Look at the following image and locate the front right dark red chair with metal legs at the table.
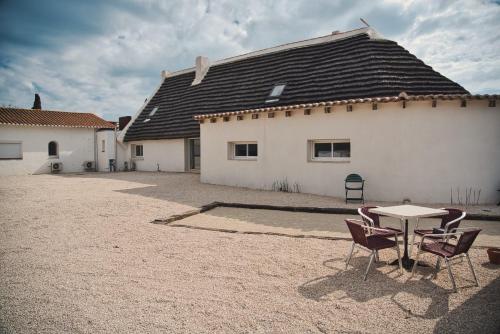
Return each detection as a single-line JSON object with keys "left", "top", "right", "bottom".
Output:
{"left": 411, "top": 228, "right": 481, "bottom": 292}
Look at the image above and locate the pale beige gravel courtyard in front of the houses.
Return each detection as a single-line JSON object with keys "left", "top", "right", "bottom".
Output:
{"left": 0, "top": 173, "right": 500, "bottom": 333}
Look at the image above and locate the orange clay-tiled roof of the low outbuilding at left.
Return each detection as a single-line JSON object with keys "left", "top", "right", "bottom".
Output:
{"left": 0, "top": 107, "right": 115, "bottom": 129}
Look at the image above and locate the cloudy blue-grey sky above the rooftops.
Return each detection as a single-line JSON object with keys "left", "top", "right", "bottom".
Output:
{"left": 0, "top": 0, "right": 500, "bottom": 120}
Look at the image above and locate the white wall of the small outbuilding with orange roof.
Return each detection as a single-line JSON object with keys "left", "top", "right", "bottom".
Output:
{"left": 0, "top": 125, "right": 95, "bottom": 175}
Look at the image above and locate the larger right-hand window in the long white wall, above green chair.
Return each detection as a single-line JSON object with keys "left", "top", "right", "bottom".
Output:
{"left": 309, "top": 139, "right": 351, "bottom": 161}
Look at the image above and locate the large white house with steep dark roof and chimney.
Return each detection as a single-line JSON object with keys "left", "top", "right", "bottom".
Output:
{"left": 120, "top": 28, "right": 500, "bottom": 203}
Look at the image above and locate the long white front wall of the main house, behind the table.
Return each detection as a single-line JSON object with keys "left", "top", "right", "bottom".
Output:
{"left": 201, "top": 100, "right": 500, "bottom": 203}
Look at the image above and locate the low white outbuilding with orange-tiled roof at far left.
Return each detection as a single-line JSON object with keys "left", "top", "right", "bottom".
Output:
{"left": 0, "top": 108, "right": 116, "bottom": 175}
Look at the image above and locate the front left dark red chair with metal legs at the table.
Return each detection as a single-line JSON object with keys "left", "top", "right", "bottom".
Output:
{"left": 345, "top": 219, "right": 403, "bottom": 281}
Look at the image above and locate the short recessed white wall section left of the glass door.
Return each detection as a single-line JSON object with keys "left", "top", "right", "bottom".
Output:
{"left": 127, "top": 139, "right": 185, "bottom": 172}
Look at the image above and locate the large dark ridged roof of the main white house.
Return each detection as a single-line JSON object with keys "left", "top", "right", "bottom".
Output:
{"left": 125, "top": 33, "right": 468, "bottom": 141}
